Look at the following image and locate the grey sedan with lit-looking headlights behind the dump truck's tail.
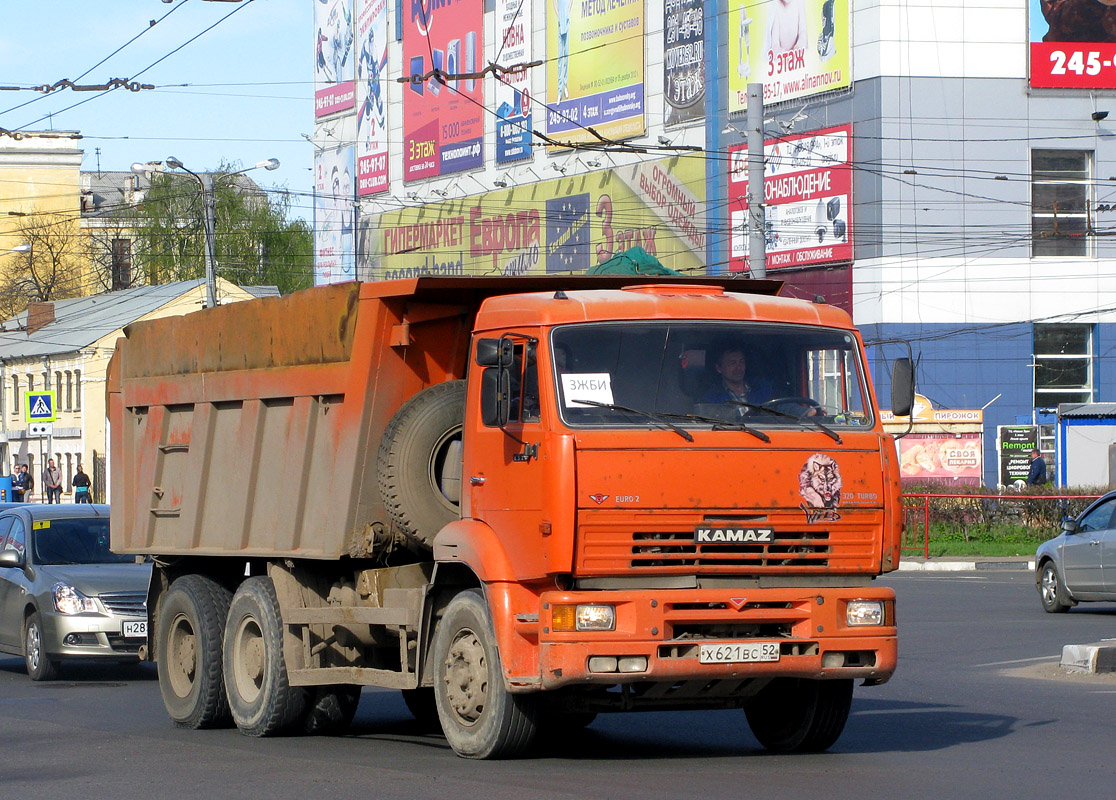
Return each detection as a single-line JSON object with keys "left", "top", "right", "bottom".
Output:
{"left": 0, "top": 504, "right": 151, "bottom": 681}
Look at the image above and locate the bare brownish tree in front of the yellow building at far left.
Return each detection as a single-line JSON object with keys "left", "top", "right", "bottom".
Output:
{"left": 0, "top": 211, "right": 85, "bottom": 319}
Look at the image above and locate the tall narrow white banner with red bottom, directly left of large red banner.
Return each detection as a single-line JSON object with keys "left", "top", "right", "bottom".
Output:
{"left": 356, "top": 0, "right": 387, "bottom": 197}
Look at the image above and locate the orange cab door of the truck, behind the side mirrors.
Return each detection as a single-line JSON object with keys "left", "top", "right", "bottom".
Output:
{"left": 462, "top": 330, "right": 550, "bottom": 578}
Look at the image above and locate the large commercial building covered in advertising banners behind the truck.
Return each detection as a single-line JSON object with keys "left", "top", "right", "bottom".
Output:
{"left": 308, "top": 0, "right": 1116, "bottom": 485}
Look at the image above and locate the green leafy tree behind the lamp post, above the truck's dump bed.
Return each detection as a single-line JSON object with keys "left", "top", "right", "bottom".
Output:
{"left": 128, "top": 164, "right": 314, "bottom": 295}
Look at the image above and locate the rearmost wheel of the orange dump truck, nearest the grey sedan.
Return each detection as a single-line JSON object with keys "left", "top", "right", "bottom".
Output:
{"left": 155, "top": 575, "right": 232, "bottom": 729}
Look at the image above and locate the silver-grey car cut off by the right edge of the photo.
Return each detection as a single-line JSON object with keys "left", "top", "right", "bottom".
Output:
{"left": 1035, "top": 492, "right": 1116, "bottom": 614}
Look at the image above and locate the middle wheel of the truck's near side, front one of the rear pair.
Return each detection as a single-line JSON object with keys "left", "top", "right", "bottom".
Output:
{"left": 224, "top": 577, "right": 307, "bottom": 736}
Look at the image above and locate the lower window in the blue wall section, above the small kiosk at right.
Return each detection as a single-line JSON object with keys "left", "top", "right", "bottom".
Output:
{"left": 1035, "top": 324, "right": 1093, "bottom": 408}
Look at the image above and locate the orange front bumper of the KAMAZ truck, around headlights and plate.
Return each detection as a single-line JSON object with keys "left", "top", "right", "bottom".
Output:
{"left": 539, "top": 587, "right": 897, "bottom": 690}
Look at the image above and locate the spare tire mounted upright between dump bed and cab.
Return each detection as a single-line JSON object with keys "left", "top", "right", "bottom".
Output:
{"left": 376, "top": 380, "right": 465, "bottom": 548}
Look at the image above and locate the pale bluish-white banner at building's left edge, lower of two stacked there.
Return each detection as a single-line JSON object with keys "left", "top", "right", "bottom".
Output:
{"left": 314, "top": 145, "right": 356, "bottom": 286}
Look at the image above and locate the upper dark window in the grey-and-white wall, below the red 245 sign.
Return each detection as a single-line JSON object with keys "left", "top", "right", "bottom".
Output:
{"left": 1031, "top": 150, "right": 1093, "bottom": 257}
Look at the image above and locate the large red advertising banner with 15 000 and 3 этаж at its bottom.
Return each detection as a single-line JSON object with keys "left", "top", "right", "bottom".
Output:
{"left": 403, "top": 0, "right": 485, "bottom": 182}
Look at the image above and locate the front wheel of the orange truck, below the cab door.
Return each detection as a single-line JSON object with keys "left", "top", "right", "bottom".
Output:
{"left": 434, "top": 589, "right": 537, "bottom": 759}
